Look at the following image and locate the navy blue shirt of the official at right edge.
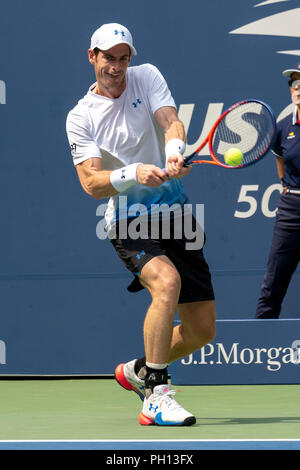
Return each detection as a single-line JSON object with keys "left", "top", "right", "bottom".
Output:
{"left": 272, "top": 108, "right": 300, "bottom": 188}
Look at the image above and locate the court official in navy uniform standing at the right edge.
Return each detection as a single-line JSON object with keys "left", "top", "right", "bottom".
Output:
{"left": 255, "top": 62, "right": 300, "bottom": 319}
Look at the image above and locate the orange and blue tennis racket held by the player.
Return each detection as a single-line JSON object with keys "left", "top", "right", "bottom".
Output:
{"left": 185, "top": 100, "right": 276, "bottom": 170}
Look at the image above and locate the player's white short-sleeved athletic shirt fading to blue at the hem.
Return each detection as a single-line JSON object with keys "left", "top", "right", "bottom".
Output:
{"left": 66, "top": 64, "right": 187, "bottom": 231}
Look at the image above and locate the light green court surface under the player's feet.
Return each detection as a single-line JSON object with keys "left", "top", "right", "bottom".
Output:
{"left": 0, "top": 378, "right": 300, "bottom": 440}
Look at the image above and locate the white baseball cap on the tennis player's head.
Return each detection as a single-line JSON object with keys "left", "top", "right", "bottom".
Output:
{"left": 91, "top": 23, "right": 137, "bottom": 55}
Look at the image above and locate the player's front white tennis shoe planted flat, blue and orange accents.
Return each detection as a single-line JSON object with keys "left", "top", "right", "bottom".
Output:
{"left": 139, "top": 384, "right": 196, "bottom": 426}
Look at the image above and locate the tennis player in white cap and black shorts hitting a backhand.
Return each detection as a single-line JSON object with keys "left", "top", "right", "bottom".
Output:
{"left": 67, "top": 23, "right": 216, "bottom": 426}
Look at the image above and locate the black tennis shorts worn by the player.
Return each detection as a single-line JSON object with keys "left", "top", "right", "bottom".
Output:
{"left": 110, "top": 217, "right": 215, "bottom": 303}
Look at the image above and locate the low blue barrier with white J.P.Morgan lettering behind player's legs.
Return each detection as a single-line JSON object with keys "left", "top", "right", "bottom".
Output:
{"left": 170, "top": 320, "right": 300, "bottom": 385}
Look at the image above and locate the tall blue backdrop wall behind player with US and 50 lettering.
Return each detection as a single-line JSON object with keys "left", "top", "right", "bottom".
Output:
{"left": 0, "top": 0, "right": 300, "bottom": 378}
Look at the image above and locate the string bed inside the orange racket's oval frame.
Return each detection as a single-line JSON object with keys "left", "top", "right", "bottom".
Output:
{"left": 211, "top": 102, "right": 274, "bottom": 165}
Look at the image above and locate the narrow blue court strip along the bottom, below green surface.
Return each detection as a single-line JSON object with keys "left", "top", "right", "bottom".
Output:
{"left": 0, "top": 439, "right": 300, "bottom": 450}
